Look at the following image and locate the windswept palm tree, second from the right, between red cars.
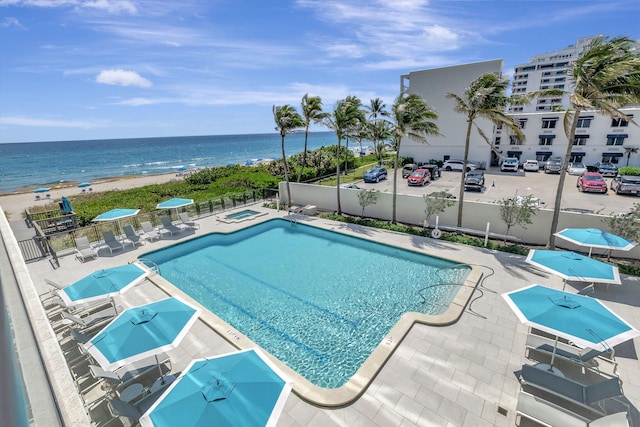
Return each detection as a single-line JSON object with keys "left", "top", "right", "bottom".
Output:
{"left": 447, "top": 73, "right": 524, "bottom": 227}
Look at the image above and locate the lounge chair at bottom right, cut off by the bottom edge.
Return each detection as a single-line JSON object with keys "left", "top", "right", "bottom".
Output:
{"left": 516, "top": 391, "right": 629, "bottom": 427}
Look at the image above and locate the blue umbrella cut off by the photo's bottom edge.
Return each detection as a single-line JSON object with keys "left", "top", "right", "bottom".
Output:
{"left": 140, "top": 349, "right": 292, "bottom": 427}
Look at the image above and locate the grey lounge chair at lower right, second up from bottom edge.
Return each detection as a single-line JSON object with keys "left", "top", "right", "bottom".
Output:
{"left": 520, "top": 365, "right": 626, "bottom": 415}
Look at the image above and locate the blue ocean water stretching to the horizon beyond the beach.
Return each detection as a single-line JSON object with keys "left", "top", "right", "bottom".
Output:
{"left": 0, "top": 132, "right": 337, "bottom": 194}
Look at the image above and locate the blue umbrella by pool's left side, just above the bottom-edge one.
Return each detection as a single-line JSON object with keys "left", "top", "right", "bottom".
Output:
{"left": 84, "top": 297, "right": 200, "bottom": 370}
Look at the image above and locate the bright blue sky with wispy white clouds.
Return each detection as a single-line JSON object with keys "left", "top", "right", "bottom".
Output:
{"left": 0, "top": 0, "right": 640, "bottom": 142}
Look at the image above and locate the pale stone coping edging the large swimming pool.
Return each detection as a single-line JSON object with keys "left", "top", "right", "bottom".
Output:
{"left": 141, "top": 213, "right": 483, "bottom": 407}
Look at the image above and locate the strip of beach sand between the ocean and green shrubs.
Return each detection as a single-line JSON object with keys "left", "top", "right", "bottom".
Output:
{"left": 0, "top": 173, "right": 182, "bottom": 221}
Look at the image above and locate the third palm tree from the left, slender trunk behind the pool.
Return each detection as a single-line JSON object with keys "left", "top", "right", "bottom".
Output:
{"left": 323, "top": 96, "right": 364, "bottom": 215}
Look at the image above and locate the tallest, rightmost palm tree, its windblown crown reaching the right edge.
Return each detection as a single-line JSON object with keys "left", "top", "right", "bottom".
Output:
{"left": 548, "top": 36, "right": 640, "bottom": 249}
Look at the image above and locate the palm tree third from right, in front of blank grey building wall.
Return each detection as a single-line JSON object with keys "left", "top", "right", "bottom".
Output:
{"left": 390, "top": 93, "right": 440, "bottom": 223}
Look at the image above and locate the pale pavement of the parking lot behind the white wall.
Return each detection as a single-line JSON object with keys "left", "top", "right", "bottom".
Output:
{"left": 356, "top": 168, "right": 640, "bottom": 215}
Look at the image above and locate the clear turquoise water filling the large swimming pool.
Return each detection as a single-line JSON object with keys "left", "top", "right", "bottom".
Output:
{"left": 145, "top": 219, "right": 470, "bottom": 388}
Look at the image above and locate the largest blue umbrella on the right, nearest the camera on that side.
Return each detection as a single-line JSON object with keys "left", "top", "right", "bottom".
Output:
{"left": 502, "top": 285, "right": 640, "bottom": 351}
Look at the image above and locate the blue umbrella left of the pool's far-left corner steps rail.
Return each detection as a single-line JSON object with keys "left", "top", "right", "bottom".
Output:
{"left": 59, "top": 264, "right": 149, "bottom": 306}
